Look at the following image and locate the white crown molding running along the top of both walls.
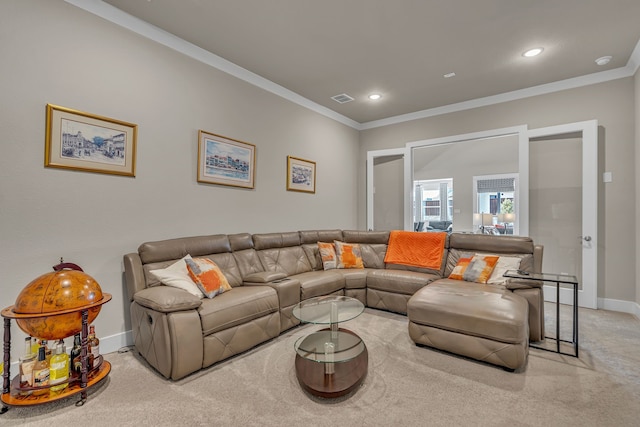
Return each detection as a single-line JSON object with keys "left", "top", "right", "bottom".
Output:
{"left": 65, "top": 0, "right": 640, "bottom": 131}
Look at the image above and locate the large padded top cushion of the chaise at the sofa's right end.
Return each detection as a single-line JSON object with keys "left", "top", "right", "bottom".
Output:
{"left": 407, "top": 279, "right": 529, "bottom": 343}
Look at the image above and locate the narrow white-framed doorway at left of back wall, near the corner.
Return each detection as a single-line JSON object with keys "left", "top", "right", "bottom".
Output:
{"left": 367, "top": 148, "right": 412, "bottom": 230}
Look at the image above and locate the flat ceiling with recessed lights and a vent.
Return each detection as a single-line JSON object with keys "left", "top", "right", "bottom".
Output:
{"left": 82, "top": 0, "right": 640, "bottom": 128}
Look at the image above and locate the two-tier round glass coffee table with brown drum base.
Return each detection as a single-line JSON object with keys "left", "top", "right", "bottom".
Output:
{"left": 293, "top": 296, "right": 369, "bottom": 398}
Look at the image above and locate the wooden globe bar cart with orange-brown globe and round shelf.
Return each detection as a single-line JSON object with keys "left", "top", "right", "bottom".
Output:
{"left": 0, "top": 263, "right": 111, "bottom": 414}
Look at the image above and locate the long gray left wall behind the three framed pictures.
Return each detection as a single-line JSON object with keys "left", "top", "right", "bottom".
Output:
{"left": 0, "top": 0, "right": 359, "bottom": 356}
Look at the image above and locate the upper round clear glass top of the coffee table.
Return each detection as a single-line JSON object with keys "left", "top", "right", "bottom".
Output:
{"left": 293, "top": 295, "right": 364, "bottom": 325}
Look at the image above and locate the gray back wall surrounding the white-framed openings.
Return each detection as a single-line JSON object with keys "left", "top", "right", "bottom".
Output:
{"left": 358, "top": 77, "right": 640, "bottom": 301}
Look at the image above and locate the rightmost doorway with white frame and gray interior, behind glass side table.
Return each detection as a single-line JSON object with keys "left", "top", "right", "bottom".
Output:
{"left": 529, "top": 120, "right": 598, "bottom": 308}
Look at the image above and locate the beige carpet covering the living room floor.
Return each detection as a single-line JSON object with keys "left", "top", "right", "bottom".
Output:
{"left": 0, "top": 304, "right": 640, "bottom": 427}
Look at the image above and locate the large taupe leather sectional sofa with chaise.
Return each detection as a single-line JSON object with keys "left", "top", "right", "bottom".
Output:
{"left": 124, "top": 230, "right": 544, "bottom": 380}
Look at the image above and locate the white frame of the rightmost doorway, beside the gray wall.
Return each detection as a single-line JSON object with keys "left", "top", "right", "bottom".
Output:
{"left": 527, "top": 120, "right": 599, "bottom": 309}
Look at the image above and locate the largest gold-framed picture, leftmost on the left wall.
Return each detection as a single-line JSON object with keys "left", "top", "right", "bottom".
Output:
{"left": 44, "top": 104, "right": 138, "bottom": 176}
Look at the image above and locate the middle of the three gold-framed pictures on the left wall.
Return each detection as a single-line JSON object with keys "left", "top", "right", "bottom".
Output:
{"left": 198, "top": 130, "right": 256, "bottom": 188}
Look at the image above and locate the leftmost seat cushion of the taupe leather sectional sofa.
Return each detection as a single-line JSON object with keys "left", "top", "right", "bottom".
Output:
{"left": 198, "top": 286, "right": 278, "bottom": 336}
